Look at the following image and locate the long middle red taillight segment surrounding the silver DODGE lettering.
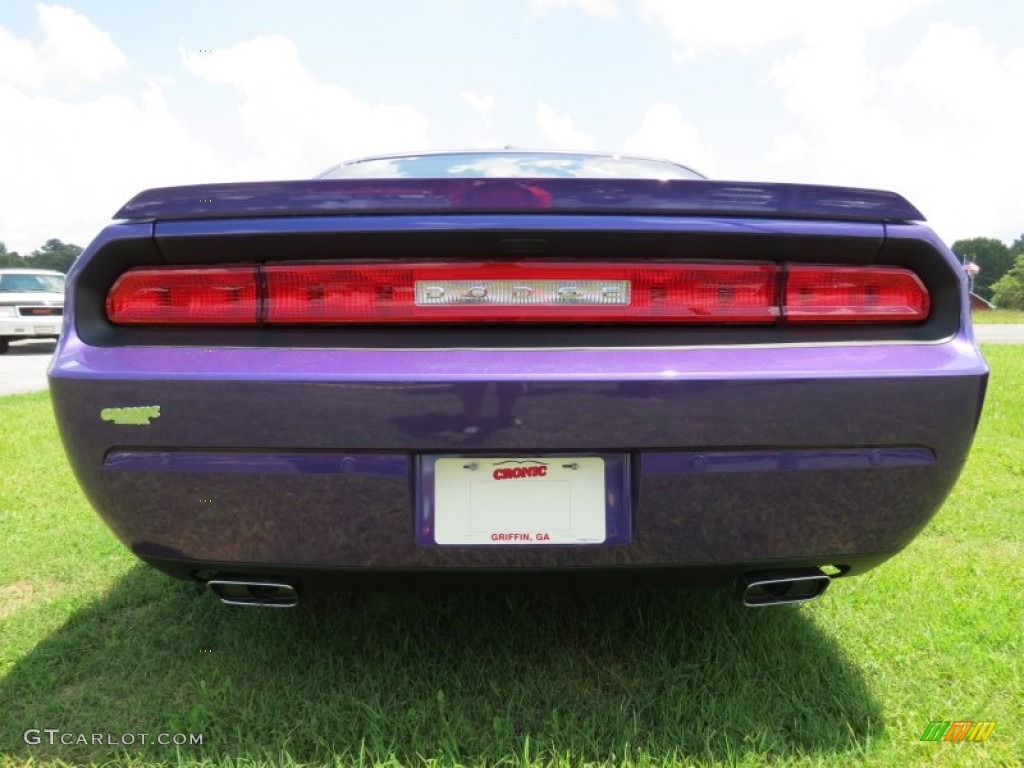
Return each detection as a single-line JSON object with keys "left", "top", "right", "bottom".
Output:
{"left": 264, "top": 262, "right": 778, "bottom": 324}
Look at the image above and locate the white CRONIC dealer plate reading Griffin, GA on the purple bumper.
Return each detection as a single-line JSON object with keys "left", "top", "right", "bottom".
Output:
{"left": 433, "top": 456, "right": 607, "bottom": 547}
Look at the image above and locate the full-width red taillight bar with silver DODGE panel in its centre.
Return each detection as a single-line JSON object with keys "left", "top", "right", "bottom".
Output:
{"left": 106, "top": 261, "right": 929, "bottom": 326}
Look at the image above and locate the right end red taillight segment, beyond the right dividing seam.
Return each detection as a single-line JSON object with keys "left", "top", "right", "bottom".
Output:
{"left": 782, "top": 264, "right": 930, "bottom": 323}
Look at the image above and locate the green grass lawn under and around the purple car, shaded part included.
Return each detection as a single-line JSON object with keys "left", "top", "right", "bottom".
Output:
{"left": 0, "top": 345, "right": 1024, "bottom": 768}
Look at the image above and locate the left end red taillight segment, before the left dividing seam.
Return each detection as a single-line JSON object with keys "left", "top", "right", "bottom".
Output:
{"left": 106, "top": 266, "right": 259, "bottom": 325}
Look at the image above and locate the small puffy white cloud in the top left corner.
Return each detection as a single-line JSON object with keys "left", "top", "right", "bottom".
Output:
{"left": 0, "top": 3, "right": 127, "bottom": 90}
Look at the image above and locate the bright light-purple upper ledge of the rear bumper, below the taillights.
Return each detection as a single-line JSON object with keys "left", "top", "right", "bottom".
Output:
{"left": 50, "top": 334, "right": 985, "bottom": 387}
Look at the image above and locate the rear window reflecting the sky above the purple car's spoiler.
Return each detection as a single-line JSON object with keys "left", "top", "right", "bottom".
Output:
{"left": 317, "top": 152, "right": 703, "bottom": 180}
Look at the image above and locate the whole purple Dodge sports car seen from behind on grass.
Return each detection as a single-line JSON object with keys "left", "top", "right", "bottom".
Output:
{"left": 49, "top": 151, "right": 988, "bottom": 606}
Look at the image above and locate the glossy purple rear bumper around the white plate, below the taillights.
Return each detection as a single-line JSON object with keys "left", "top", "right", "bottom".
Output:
{"left": 50, "top": 337, "right": 987, "bottom": 581}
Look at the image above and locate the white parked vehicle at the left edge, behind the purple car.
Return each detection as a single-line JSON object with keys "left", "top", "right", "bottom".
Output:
{"left": 0, "top": 268, "right": 65, "bottom": 354}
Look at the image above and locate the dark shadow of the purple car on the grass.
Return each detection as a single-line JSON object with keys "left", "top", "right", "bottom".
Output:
{"left": 0, "top": 565, "right": 883, "bottom": 765}
